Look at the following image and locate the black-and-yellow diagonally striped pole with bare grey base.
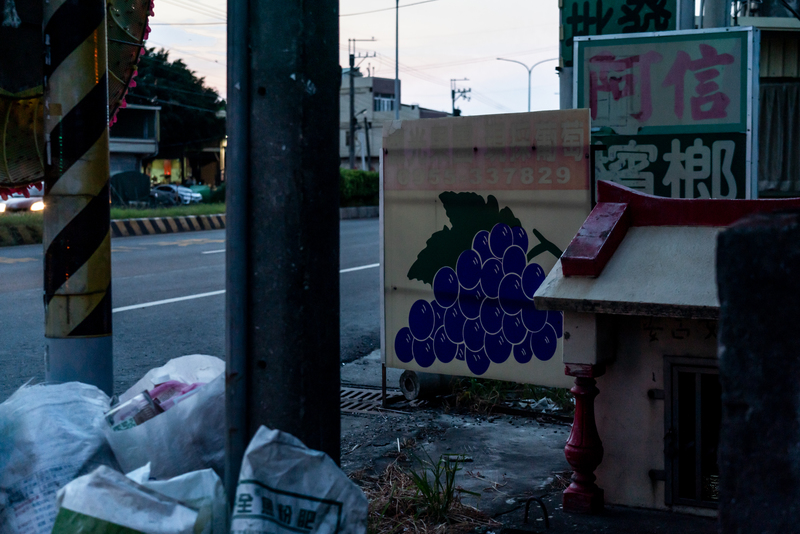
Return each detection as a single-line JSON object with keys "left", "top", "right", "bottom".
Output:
{"left": 43, "top": 0, "right": 114, "bottom": 395}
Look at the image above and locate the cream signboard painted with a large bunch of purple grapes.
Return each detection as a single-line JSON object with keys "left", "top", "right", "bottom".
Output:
{"left": 381, "top": 110, "right": 590, "bottom": 387}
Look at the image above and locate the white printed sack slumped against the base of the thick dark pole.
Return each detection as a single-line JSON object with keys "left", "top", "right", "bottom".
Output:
{"left": 231, "top": 426, "right": 368, "bottom": 534}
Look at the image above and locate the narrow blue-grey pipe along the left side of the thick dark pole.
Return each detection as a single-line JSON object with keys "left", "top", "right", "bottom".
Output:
{"left": 225, "top": 0, "right": 252, "bottom": 502}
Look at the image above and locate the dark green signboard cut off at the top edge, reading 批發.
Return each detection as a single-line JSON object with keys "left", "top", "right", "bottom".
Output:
{"left": 561, "top": 0, "right": 679, "bottom": 67}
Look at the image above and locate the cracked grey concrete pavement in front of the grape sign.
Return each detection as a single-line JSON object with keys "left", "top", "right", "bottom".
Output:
{"left": 341, "top": 351, "right": 717, "bottom": 534}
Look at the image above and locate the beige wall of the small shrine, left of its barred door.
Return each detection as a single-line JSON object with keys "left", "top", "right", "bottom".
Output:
{"left": 595, "top": 316, "right": 717, "bottom": 515}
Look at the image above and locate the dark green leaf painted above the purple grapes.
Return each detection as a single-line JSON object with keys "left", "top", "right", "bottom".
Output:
{"left": 408, "top": 191, "right": 522, "bottom": 284}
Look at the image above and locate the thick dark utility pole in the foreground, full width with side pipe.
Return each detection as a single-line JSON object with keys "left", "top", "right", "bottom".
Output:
{"left": 225, "top": 0, "right": 341, "bottom": 498}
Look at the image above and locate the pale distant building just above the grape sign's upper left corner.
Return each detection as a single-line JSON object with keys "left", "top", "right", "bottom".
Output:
{"left": 339, "top": 69, "right": 452, "bottom": 170}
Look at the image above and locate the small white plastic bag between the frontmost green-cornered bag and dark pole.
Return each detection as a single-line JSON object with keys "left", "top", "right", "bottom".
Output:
{"left": 128, "top": 464, "right": 228, "bottom": 534}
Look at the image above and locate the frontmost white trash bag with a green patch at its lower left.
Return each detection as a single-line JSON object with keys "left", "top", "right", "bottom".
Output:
{"left": 53, "top": 467, "right": 197, "bottom": 534}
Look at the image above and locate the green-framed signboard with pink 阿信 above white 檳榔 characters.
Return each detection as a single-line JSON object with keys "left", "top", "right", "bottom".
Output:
{"left": 574, "top": 28, "right": 758, "bottom": 198}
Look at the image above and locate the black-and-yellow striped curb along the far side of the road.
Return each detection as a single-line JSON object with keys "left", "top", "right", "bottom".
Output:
{"left": 0, "top": 206, "right": 378, "bottom": 247}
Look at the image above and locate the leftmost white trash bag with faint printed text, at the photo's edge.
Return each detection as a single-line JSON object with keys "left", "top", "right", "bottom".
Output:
{"left": 0, "top": 382, "right": 117, "bottom": 534}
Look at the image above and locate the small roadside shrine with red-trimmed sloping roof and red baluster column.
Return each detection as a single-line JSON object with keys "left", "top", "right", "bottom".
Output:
{"left": 534, "top": 181, "right": 800, "bottom": 515}
